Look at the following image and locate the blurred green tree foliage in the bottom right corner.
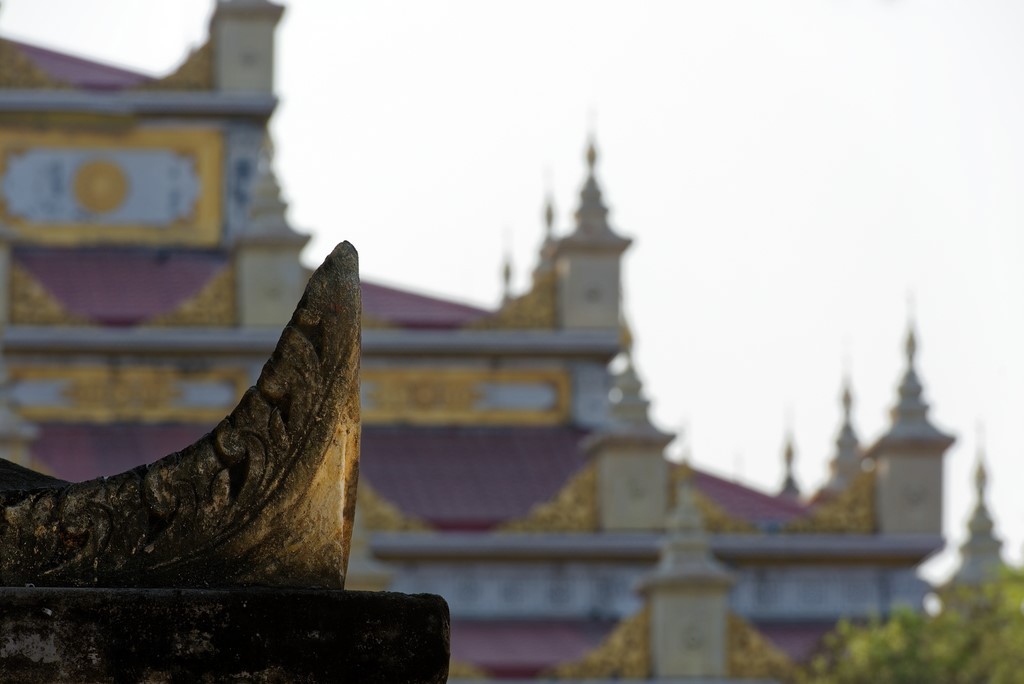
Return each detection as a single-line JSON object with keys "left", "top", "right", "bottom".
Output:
{"left": 799, "top": 570, "right": 1024, "bottom": 684}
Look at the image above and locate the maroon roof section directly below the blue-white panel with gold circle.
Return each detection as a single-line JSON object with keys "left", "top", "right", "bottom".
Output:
{"left": 14, "top": 248, "right": 227, "bottom": 326}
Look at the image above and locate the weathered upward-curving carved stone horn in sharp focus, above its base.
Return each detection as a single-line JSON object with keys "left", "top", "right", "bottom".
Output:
{"left": 0, "top": 243, "right": 360, "bottom": 589}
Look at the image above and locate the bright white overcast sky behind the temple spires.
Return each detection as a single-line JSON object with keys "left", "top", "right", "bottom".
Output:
{"left": 0, "top": 0, "right": 1024, "bottom": 576}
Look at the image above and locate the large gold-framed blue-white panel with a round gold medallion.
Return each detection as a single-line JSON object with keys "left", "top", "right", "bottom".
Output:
{"left": 0, "top": 128, "right": 223, "bottom": 247}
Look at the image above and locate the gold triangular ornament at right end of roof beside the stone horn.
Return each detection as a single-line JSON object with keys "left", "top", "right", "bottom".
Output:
{"left": 497, "top": 461, "right": 598, "bottom": 533}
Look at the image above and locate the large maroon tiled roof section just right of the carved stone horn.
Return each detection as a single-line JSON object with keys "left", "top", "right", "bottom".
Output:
{"left": 359, "top": 426, "right": 586, "bottom": 530}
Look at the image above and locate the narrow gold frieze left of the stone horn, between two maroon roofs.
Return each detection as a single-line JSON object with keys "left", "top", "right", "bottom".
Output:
{"left": 10, "top": 366, "right": 249, "bottom": 423}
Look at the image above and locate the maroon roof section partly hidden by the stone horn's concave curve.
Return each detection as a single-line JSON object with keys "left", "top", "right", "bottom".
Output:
{"left": 32, "top": 423, "right": 210, "bottom": 482}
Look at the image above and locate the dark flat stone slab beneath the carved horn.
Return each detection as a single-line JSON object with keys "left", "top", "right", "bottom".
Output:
{"left": 0, "top": 587, "right": 449, "bottom": 684}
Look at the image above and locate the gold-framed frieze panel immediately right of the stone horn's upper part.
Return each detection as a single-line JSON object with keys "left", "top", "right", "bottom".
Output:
{"left": 362, "top": 367, "right": 569, "bottom": 425}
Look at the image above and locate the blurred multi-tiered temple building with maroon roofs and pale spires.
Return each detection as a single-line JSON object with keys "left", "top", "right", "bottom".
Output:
{"left": 0, "top": 0, "right": 998, "bottom": 681}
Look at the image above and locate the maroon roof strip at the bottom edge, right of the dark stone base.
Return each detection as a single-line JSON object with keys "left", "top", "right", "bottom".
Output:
{"left": 452, "top": 621, "right": 615, "bottom": 679}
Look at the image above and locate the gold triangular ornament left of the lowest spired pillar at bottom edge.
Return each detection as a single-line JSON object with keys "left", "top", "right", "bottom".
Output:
{"left": 541, "top": 606, "right": 650, "bottom": 680}
